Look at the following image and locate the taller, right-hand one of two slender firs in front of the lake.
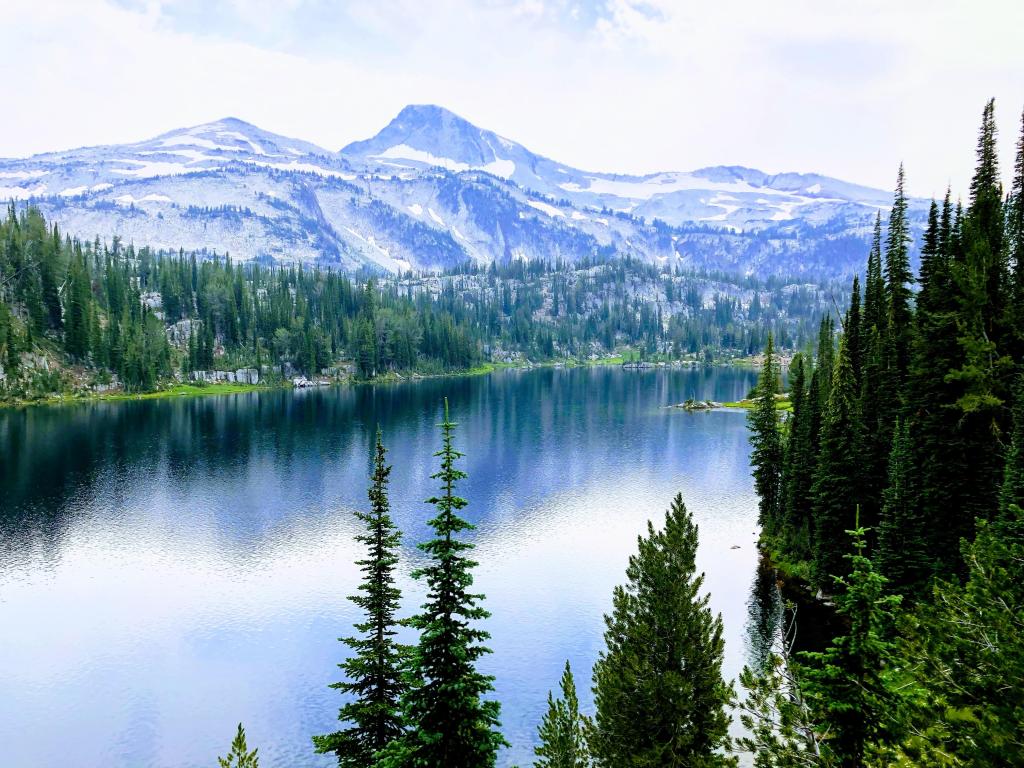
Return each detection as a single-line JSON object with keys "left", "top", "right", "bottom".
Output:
{"left": 382, "top": 399, "right": 505, "bottom": 768}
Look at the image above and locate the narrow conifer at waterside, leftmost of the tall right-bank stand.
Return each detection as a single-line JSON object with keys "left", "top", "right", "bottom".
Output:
{"left": 748, "top": 334, "right": 782, "bottom": 536}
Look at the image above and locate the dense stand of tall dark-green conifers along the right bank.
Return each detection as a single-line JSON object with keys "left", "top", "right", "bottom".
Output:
{"left": 744, "top": 101, "right": 1024, "bottom": 766}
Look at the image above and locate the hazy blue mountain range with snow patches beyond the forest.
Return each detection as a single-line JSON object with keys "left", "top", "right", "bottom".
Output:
{"left": 0, "top": 105, "right": 925, "bottom": 278}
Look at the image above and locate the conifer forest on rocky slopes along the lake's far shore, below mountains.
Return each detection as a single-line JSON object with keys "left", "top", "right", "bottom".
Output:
{"left": 0, "top": 206, "right": 834, "bottom": 397}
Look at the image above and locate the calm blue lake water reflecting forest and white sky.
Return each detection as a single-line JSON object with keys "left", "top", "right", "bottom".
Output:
{"left": 0, "top": 369, "right": 770, "bottom": 768}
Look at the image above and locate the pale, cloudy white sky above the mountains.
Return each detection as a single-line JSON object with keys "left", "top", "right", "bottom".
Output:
{"left": 0, "top": 0, "right": 1024, "bottom": 197}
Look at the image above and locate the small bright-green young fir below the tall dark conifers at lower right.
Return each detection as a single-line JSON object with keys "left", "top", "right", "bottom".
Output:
{"left": 801, "top": 523, "right": 902, "bottom": 768}
